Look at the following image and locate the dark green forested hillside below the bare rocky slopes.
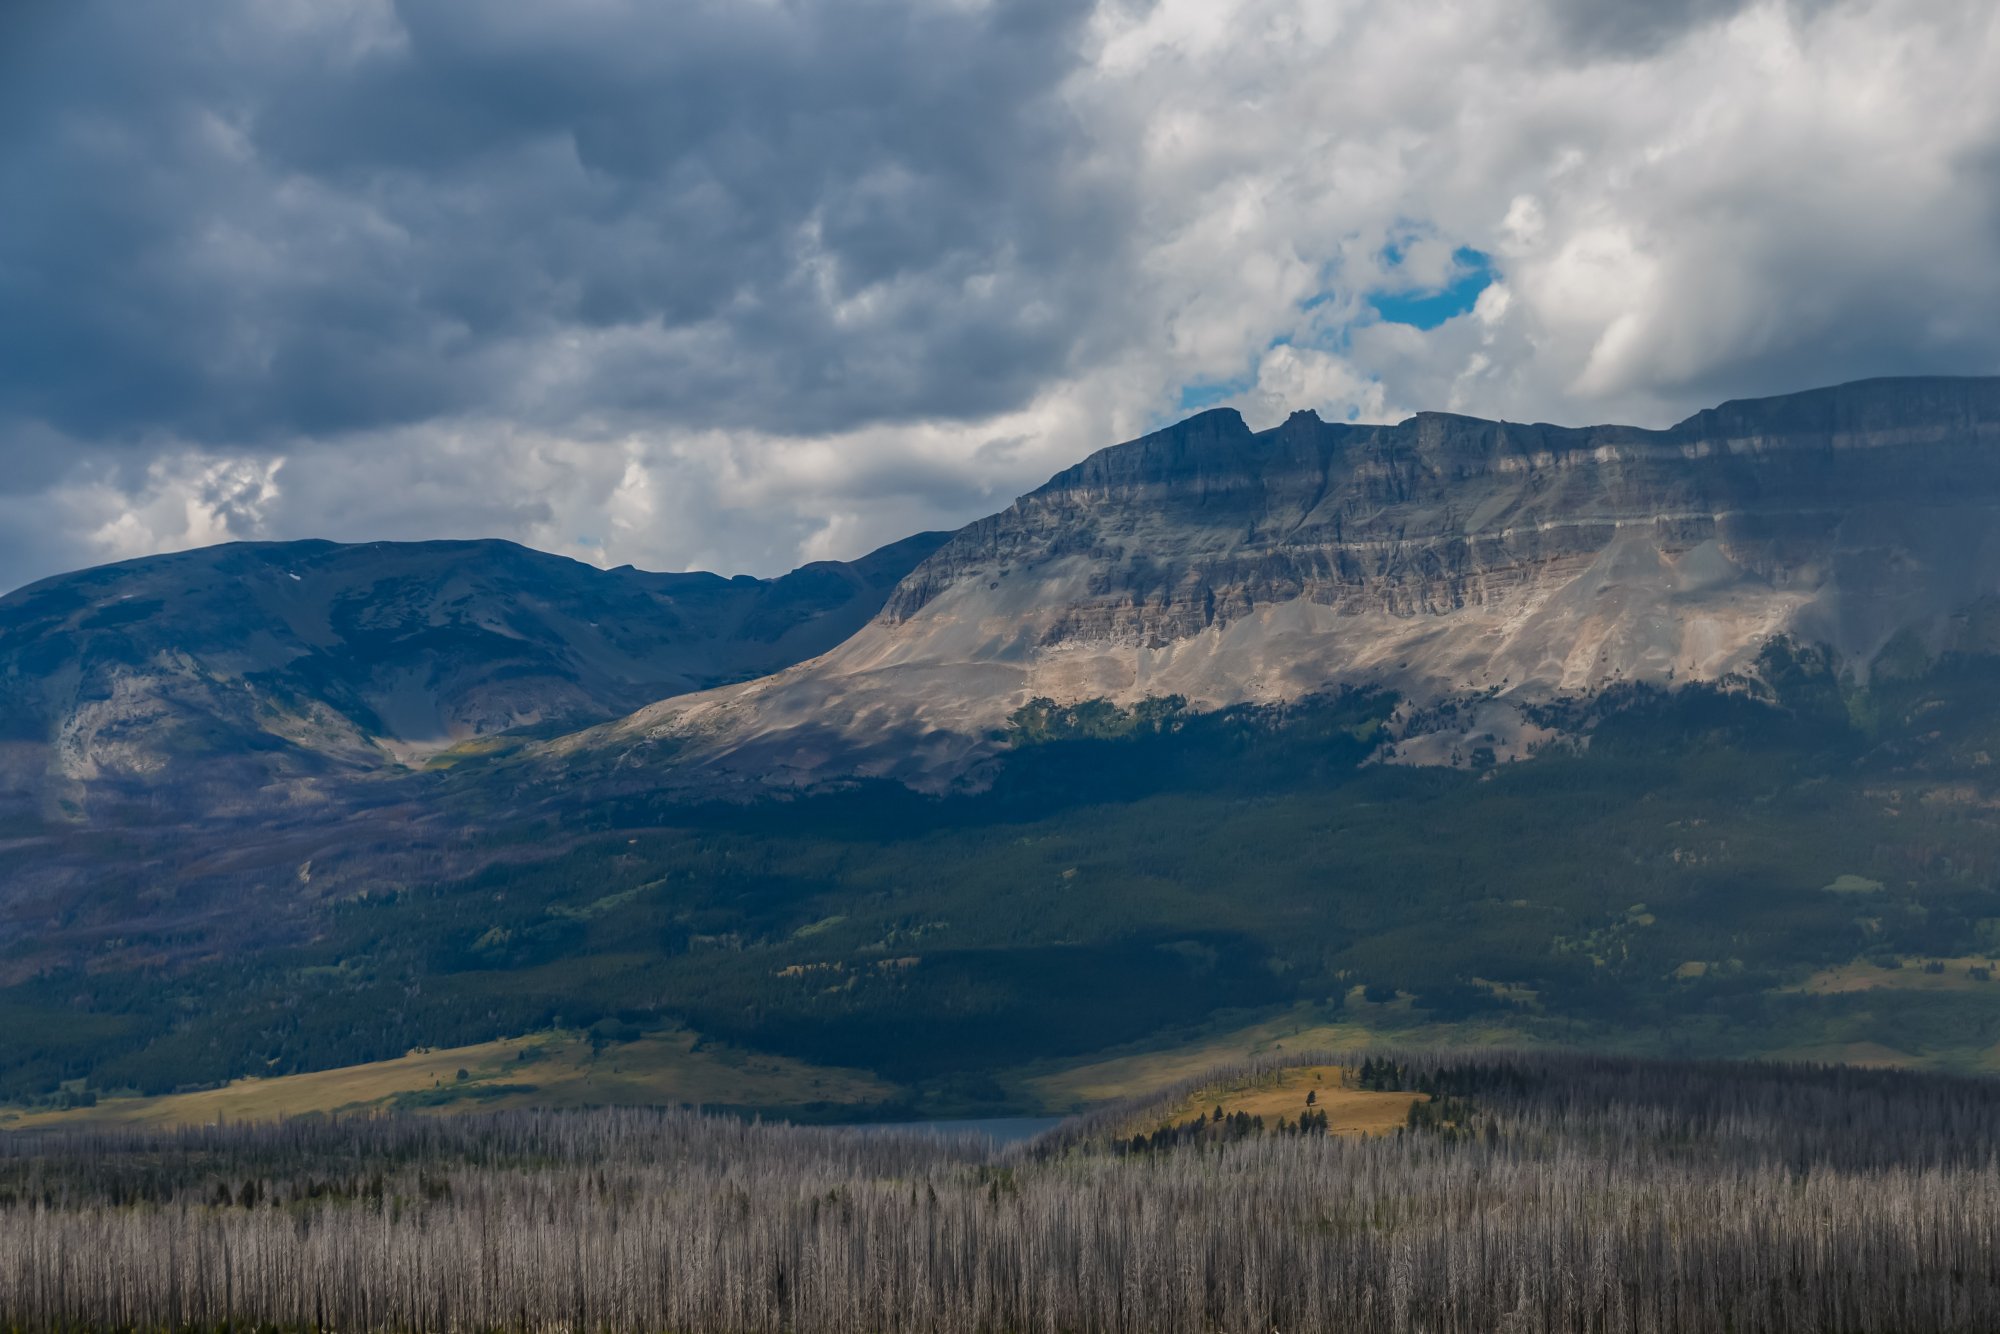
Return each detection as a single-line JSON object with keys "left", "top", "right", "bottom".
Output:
{"left": 11, "top": 644, "right": 2000, "bottom": 1110}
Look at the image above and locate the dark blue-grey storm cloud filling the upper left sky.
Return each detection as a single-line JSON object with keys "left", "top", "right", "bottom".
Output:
{"left": 0, "top": 0, "right": 1122, "bottom": 444}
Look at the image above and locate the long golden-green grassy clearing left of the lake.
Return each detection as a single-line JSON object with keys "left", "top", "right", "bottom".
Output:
{"left": 0, "top": 1030, "right": 898, "bottom": 1130}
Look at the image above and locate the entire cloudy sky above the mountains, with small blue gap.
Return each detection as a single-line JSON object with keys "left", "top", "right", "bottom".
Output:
{"left": 0, "top": 0, "right": 2000, "bottom": 588}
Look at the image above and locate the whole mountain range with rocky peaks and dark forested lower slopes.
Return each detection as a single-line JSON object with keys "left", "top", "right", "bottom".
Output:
{"left": 15, "top": 370, "right": 2000, "bottom": 1120}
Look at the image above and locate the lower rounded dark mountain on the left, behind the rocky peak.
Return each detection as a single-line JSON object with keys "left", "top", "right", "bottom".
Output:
{"left": 0, "top": 534, "right": 944, "bottom": 810}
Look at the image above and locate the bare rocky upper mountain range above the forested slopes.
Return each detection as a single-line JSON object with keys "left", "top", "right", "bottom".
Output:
{"left": 0, "top": 378, "right": 2000, "bottom": 810}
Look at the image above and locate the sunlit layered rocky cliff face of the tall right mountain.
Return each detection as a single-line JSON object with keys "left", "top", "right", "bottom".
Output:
{"left": 554, "top": 378, "right": 2000, "bottom": 786}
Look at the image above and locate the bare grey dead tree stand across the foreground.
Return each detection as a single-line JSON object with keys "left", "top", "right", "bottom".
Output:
{"left": 0, "top": 1054, "right": 2000, "bottom": 1334}
